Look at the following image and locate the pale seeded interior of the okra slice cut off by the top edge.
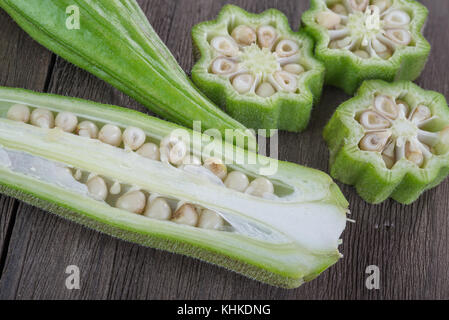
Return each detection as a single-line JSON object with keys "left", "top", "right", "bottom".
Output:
{"left": 316, "top": 0, "right": 415, "bottom": 60}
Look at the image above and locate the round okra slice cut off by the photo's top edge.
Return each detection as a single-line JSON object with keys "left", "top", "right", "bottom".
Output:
{"left": 302, "top": 0, "right": 430, "bottom": 94}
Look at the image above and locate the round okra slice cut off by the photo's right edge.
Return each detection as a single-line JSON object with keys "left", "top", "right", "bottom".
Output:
{"left": 324, "top": 80, "right": 449, "bottom": 204}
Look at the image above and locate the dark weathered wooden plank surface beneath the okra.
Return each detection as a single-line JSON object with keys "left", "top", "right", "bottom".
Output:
{"left": 0, "top": 0, "right": 449, "bottom": 299}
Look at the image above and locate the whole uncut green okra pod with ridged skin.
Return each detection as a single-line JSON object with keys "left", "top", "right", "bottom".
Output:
{"left": 0, "top": 0, "right": 253, "bottom": 145}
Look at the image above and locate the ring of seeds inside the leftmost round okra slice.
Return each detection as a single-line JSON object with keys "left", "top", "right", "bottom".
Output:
{"left": 210, "top": 25, "right": 305, "bottom": 97}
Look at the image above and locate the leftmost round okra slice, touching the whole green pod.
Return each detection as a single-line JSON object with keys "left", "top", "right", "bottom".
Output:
{"left": 192, "top": 5, "right": 324, "bottom": 131}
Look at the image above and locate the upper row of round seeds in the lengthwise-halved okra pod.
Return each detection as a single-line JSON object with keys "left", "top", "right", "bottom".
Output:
{"left": 7, "top": 104, "right": 274, "bottom": 197}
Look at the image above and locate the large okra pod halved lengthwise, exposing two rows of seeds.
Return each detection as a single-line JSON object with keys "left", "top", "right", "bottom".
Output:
{"left": 0, "top": 88, "right": 348, "bottom": 288}
